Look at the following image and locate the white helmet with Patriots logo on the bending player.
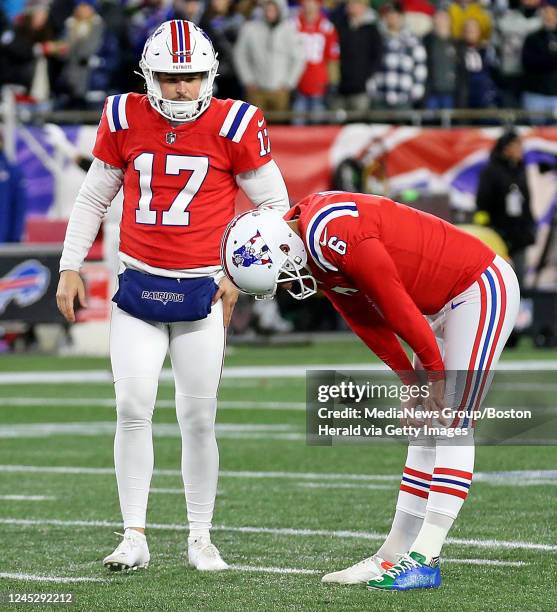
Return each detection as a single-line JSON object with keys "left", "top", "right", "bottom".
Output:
{"left": 221, "top": 208, "right": 317, "bottom": 300}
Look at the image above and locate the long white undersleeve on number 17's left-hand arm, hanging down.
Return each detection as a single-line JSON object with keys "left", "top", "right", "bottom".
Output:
{"left": 60, "top": 158, "right": 124, "bottom": 272}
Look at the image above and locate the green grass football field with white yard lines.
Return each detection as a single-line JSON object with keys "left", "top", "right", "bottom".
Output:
{"left": 0, "top": 342, "right": 557, "bottom": 611}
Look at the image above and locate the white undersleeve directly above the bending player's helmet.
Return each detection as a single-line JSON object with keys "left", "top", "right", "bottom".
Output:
{"left": 236, "top": 160, "right": 290, "bottom": 215}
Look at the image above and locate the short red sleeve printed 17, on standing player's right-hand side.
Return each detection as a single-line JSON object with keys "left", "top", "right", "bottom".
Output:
{"left": 229, "top": 107, "right": 272, "bottom": 174}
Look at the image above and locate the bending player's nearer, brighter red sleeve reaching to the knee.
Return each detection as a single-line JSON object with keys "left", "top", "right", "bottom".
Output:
{"left": 338, "top": 238, "right": 445, "bottom": 379}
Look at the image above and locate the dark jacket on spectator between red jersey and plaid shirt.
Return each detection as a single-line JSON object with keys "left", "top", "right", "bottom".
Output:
{"left": 331, "top": 10, "right": 383, "bottom": 96}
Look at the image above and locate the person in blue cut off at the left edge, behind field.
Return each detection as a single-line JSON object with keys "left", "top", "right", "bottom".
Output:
{"left": 0, "top": 137, "right": 27, "bottom": 243}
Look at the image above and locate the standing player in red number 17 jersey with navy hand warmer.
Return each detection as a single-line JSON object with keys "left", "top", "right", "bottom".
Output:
{"left": 57, "top": 20, "right": 288, "bottom": 570}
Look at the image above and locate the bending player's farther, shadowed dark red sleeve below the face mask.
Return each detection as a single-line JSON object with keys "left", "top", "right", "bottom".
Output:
{"left": 327, "top": 293, "right": 417, "bottom": 385}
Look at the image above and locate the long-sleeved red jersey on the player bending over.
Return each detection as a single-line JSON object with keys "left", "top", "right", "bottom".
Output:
{"left": 285, "top": 192, "right": 495, "bottom": 382}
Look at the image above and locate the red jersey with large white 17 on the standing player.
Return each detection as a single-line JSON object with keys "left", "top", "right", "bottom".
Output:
{"left": 93, "top": 93, "right": 271, "bottom": 269}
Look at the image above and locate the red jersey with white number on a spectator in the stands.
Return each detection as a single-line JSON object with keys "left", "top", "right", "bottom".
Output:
{"left": 296, "top": 13, "right": 339, "bottom": 96}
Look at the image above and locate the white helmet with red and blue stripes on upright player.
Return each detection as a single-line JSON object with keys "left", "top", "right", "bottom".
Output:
{"left": 139, "top": 19, "right": 219, "bottom": 122}
